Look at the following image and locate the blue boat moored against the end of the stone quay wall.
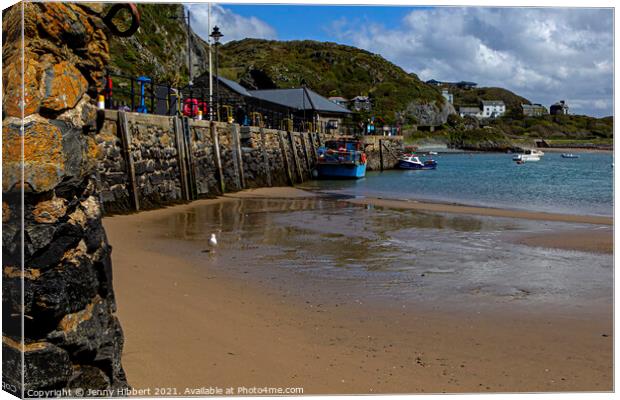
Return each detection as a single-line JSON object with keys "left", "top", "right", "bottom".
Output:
{"left": 316, "top": 138, "right": 367, "bottom": 179}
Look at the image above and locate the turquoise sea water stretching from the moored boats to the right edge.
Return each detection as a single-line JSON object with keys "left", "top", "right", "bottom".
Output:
{"left": 302, "top": 153, "right": 613, "bottom": 215}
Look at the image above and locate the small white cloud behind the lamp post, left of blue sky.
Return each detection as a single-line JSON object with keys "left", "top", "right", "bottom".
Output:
{"left": 185, "top": 4, "right": 276, "bottom": 42}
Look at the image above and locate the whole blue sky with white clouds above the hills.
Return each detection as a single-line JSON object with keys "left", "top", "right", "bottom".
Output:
{"left": 186, "top": 3, "right": 614, "bottom": 116}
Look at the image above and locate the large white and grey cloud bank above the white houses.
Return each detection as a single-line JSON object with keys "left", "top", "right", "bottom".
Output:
{"left": 330, "top": 7, "right": 613, "bottom": 116}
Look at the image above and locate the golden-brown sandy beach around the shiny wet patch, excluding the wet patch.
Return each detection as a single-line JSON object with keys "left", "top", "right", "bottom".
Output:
{"left": 104, "top": 188, "right": 613, "bottom": 395}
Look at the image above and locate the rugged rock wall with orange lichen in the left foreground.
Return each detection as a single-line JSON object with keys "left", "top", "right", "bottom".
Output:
{"left": 2, "top": 2, "right": 127, "bottom": 397}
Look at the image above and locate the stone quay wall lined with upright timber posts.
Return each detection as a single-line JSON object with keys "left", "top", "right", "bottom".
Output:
{"left": 95, "top": 110, "right": 344, "bottom": 213}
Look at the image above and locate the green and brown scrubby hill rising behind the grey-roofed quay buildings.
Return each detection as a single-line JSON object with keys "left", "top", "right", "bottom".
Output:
{"left": 220, "top": 39, "right": 444, "bottom": 123}
